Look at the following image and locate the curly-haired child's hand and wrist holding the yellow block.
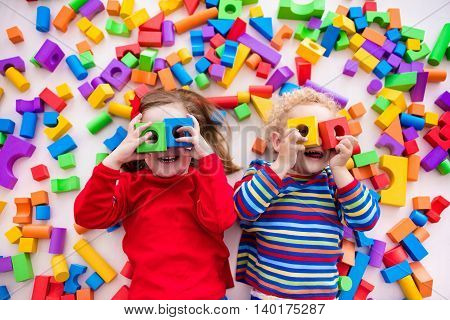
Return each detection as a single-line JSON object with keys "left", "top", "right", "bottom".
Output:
{"left": 270, "top": 128, "right": 307, "bottom": 179}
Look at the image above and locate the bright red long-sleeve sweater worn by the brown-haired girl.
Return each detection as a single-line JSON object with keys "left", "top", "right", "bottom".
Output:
{"left": 74, "top": 154, "right": 236, "bottom": 300}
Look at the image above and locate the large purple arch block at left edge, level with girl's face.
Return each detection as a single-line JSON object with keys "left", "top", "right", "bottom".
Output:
{"left": 0, "top": 134, "right": 36, "bottom": 190}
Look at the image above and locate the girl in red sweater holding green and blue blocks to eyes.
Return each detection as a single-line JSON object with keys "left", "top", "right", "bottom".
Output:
{"left": 74, "top": 90, "right": 237, "bottom": 299}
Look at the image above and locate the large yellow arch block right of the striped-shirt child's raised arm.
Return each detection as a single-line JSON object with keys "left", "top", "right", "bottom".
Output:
{"left": 379, "top": 154, "right": 408, "bottom": 207}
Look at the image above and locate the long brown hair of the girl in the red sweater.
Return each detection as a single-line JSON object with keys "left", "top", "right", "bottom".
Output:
{"left": 119, "top": 88, "right": 240, "bottom": 174}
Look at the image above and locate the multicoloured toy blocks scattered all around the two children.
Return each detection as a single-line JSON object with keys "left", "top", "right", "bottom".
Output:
{"left": 0, "top": 0, "right": 450, "bottom": 300}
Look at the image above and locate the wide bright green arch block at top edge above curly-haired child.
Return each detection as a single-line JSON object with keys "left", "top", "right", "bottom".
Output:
{"left": 278, "top": 0, "right": 325, "bottom": 21}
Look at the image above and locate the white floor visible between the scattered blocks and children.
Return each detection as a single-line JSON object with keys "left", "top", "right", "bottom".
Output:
{"left": 0, "top": 0, "right": 450, "bottom": 299}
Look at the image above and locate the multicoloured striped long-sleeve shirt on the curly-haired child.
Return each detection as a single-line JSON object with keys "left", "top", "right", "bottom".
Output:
{"left": 234, "top": 160, "right": 380, "bottom": 299}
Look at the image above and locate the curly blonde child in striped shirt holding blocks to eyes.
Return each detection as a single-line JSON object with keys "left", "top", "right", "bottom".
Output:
{"left": 234, "top": 88, "right": 380, "bottom": 299}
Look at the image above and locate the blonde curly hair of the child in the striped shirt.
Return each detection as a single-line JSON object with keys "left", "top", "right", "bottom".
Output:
{"left": 266, "top": 87, "right": 339, "bottom": 142}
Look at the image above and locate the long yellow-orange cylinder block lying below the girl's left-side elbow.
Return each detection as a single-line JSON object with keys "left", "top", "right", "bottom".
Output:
{"left": 73, "top": 239, "right": 117, "bottom": 283}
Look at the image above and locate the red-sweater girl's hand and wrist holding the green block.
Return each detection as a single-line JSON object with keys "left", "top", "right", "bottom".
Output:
{"left": 103, "top": 113, "right": 152, "bottom": 170}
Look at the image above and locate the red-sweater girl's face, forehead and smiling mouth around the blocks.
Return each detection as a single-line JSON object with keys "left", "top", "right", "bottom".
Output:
{"left": 141, "top": 103, "right": 192, "bottom": 178}
